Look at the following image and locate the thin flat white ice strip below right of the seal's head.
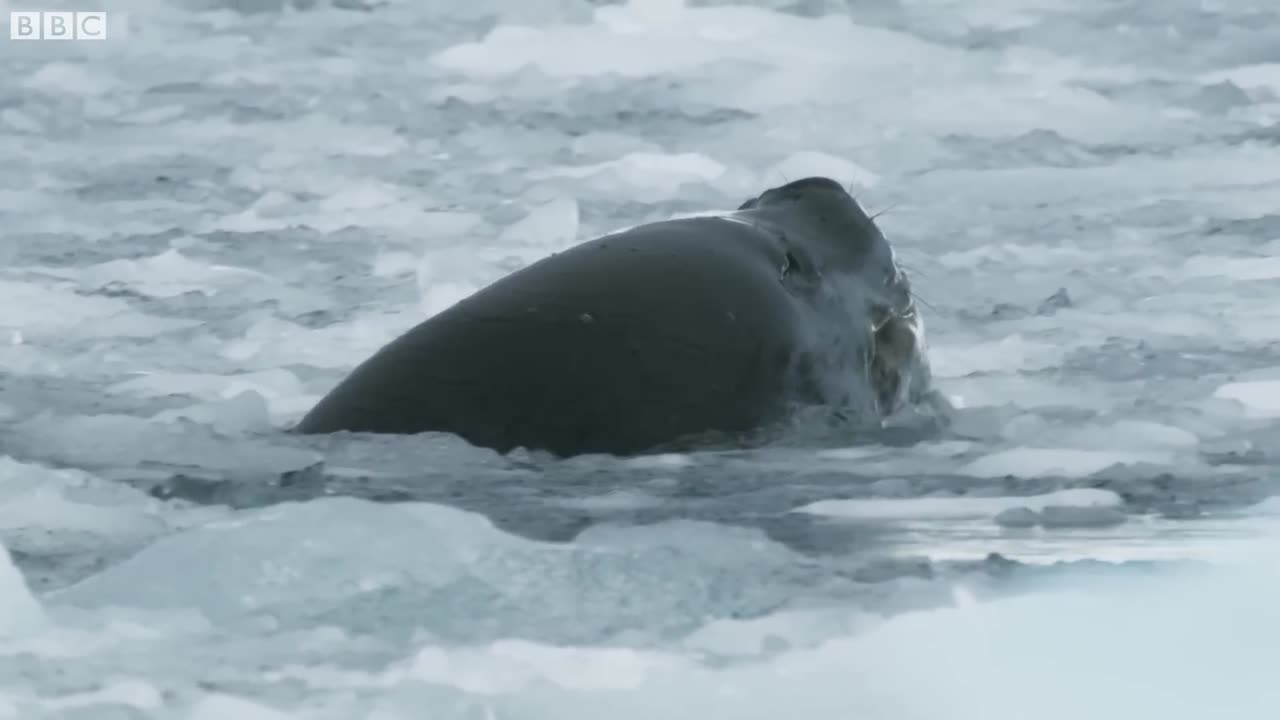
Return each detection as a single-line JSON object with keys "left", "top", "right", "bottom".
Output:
{"left": 795, "top": 488, "right": 1124, "bottom": 520}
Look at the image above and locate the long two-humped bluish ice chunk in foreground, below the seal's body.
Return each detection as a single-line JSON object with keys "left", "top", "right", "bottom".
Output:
{"left": 56, "top": 498, "right": 834, "bottom": 639}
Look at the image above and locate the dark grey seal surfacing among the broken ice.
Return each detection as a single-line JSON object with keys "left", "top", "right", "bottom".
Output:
{"left": 296, "top": 177, "right": 929, "bottom": 457}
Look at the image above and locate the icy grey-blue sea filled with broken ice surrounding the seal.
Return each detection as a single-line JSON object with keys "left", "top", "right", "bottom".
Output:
{"left": 0, "top": 0, "right": 1280, "bottom": 720}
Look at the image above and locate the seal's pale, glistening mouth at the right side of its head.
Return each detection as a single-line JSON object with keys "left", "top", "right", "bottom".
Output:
{"left": 867, "top": 278, "right": 924, "bottom": 416}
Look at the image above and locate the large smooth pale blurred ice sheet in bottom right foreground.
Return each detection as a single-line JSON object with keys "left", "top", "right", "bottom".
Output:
{"left": 450, "top": 562, "right": 1280, "bottom": 720}
